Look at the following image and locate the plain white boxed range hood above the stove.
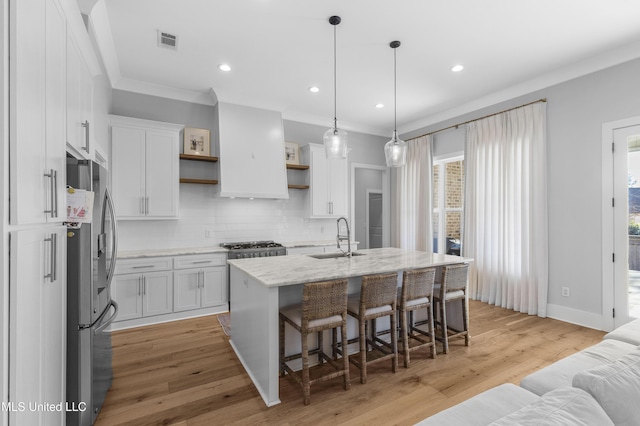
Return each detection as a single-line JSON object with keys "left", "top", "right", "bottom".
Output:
{"left": 214, "top": 102, "right": 289, "bottom": 198}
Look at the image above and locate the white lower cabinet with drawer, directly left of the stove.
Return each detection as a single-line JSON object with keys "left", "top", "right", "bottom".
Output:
{"left": 173, "top": 255, "right": 229, "bottom": 312}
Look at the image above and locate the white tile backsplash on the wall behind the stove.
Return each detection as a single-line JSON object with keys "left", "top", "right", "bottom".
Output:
{"left": 118, "top": 184, "right": 336, "bottom": 251}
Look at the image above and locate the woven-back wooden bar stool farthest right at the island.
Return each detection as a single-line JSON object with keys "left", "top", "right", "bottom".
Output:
{"left": 433, "top": 264, "right": 470, "bottom": 354}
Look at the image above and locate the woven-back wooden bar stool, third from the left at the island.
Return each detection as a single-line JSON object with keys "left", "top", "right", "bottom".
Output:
{"left": 398, "top": 268, "right": 436, "bottom": 368}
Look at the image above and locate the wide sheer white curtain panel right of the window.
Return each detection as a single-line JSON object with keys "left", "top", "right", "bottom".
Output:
{"left": 463, "top": 102, "right": 548, "bottom": 317}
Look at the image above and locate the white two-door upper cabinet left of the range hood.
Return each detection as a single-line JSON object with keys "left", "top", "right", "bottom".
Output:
{"left": 111, "top": 116, "right": 183, "bottom": 219}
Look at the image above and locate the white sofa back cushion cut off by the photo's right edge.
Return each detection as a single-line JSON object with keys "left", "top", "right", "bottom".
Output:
{"left": 573, "top": 349, "right": 640, "bottom": 425}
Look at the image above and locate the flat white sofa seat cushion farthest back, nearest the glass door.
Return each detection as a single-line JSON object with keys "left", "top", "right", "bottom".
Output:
{"left": 520, "top": 339, "right": 637, "bottom": 395}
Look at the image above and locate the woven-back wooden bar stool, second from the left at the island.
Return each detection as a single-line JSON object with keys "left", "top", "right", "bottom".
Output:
{"left": 343, "top": 273, "right": 398, "bottom": 384}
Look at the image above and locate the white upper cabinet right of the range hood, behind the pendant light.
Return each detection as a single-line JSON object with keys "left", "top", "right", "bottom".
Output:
{"left": 302, "top": 144, "right": 348, "bottom": 218}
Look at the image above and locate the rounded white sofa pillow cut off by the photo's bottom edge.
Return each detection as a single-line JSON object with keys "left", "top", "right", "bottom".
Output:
{"left": 491, "top": 386, "right": 614, "bottom": 426}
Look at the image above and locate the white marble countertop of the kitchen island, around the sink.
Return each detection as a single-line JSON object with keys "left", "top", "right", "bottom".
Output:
{"left": 227, "top": 247, "right": 472, "bottom": 287}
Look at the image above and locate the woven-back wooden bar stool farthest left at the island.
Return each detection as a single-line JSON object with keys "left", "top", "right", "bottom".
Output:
{"left": 280, "top": 280, "right": 351, "bottom": 405}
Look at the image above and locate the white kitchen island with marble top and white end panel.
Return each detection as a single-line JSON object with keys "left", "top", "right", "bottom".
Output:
{"left": 228, "top": 248, "right": 471, "bottom": 406}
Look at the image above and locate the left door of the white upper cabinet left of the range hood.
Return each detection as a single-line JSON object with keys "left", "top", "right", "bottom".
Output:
{"left": 111, "top": 126, "right": 146, "bottom": 219}
